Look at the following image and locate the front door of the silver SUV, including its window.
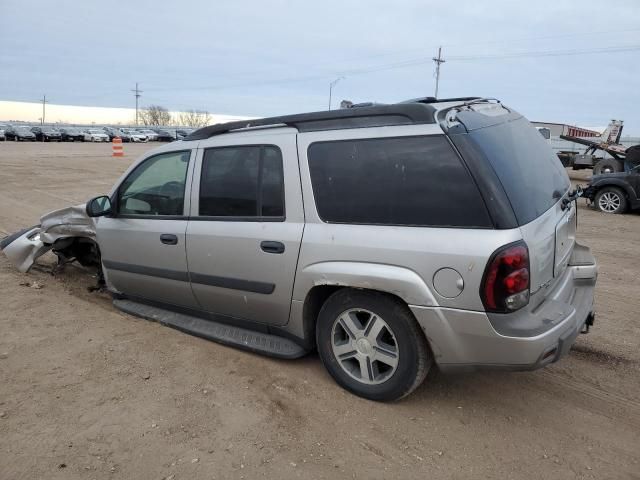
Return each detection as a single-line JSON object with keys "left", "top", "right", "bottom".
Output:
{"left": 97, "top": 150, "right": 198, "bottom": 307}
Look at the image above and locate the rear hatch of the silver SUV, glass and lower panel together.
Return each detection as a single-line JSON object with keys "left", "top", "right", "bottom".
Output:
{"left": 444, "top": 104, "right": 576, "bottom": 294}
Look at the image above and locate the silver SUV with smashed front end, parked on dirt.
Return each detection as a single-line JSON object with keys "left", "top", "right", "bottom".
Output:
{"left": 1, "top": 98, "right": 597, "bottom": 400}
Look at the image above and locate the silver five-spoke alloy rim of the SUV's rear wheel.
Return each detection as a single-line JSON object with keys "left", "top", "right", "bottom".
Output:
{"left": 331, "top": 308, "right": 400, "bottom": 385}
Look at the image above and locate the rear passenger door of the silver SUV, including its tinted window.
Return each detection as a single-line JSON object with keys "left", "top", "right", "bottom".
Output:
{"left": 187, "top": 128, "right": 304, "bottom": 325}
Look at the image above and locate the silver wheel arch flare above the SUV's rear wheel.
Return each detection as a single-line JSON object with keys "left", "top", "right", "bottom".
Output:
{"left": 294, "top": 262, "right": 438, "bottom": 307}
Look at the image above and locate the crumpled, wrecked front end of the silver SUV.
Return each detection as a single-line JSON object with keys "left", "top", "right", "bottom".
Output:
{"left": 0, "top": 205, "right": 100, "bottom": 273}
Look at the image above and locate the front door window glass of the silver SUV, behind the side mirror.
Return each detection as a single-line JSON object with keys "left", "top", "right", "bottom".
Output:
{"left": 118, "top": 151, "right": 191, "bottom": 215}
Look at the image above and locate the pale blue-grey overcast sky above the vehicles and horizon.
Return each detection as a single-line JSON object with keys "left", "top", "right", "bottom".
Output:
{"left": 0, "top": 0, "right": 640, "bottom": 135}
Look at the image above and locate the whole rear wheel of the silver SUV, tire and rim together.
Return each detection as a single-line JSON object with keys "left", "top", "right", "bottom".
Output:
{"left": 316, "top": 288, "right": 432, "bottom": 401}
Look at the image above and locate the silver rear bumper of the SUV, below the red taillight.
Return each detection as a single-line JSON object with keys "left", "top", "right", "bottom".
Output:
{"left": 410, "top": 246, "right": 597, "bottom": 371}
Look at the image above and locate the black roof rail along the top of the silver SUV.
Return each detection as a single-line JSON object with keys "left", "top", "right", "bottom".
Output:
{"left": 185, "top": 102, "right": 436, "bottom": 141}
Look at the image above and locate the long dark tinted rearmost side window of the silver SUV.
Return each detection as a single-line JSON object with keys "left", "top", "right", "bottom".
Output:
{"left": 308, "top": 135, "right": 492, "bottom": 228}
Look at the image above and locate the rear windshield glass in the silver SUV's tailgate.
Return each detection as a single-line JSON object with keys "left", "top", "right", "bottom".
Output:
{"left": 468, "top": 117, "right": 571, "bottom": 225}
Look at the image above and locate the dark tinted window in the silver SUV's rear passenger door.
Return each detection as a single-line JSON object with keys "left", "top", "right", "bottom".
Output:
{"left": 199, "top": 145, "right": 284, "bottom": 217}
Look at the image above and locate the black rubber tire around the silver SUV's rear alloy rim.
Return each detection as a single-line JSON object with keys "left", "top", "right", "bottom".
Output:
{"left": 316, "top": 288, "right": 433, "bottom": 401}
